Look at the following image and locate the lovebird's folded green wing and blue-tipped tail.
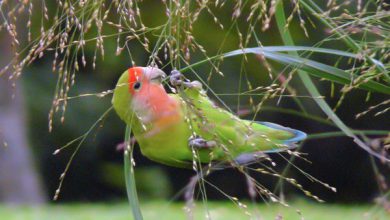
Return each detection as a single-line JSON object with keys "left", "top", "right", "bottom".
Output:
{"left": 181, "top": 88, "right": 306, "bottom": 160}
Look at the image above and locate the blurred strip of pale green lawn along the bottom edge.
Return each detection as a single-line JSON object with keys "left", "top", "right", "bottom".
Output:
{"left": 0, "top": 200, "right": 389, "bottom": 220}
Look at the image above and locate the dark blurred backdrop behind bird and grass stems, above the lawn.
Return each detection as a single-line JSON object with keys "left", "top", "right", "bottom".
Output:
{"left": 0, "top": 1, "right": 390, "bottom": 210}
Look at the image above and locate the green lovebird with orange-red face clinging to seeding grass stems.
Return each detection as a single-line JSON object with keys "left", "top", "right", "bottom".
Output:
{"left": 112, "top": 67, "right": 306, "bottom": 167}
